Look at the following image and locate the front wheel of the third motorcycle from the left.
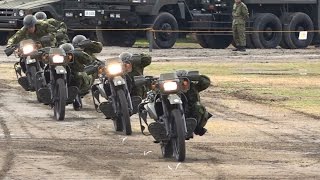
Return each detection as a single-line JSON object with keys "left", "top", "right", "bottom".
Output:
{"left": 117, "top": 89, "right": 132, "bottom": 135}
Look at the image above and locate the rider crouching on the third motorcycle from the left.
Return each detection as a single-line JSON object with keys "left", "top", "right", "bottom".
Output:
{"left": 119, "top": 52, "right": 152, "bottom": 98}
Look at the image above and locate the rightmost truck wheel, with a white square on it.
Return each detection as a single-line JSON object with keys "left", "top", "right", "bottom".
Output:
{"left": 283, "top": 12, "right": 314, "bottom": 49}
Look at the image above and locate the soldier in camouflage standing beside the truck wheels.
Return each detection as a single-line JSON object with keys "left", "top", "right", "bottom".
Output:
{"left": 232, "top": 0, "right": 249, "bottom": 51}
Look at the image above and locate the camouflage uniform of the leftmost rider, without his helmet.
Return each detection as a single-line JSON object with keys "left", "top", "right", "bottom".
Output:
{"left": 7, "top": 21, "right": 57, "bottom": 47}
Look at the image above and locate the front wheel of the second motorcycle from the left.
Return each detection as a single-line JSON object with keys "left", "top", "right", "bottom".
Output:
{"left": 54, "top": 78, "right": 67, "bottom": 121}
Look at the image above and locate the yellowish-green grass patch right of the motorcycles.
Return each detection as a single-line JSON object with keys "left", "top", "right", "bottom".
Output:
{"left": 146, "top": 62, "right": 320, "bottom": 116}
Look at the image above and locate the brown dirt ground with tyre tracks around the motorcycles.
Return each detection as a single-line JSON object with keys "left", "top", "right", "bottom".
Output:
{"left": 0, "top": 47, "right": 320, "bottom": 179}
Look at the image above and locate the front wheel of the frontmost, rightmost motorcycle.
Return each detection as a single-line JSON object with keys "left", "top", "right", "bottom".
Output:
{"left": 171, "top": 109, "right": 186, "bottom": 162}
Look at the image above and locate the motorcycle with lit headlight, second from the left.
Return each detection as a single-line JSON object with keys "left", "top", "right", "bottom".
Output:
{"left": 39, "top": 48, "right": 79, "bottom": 120}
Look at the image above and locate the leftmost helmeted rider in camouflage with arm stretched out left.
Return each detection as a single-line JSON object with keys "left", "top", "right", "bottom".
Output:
{"left": 7, "top": 15, "right": 57, "bottom": 47}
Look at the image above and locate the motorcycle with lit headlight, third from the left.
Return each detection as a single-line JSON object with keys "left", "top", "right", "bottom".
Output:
{"left": 92, "top": 58, "right": 141, "bottom": 135}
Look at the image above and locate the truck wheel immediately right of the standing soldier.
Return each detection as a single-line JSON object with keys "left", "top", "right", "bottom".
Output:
{"left": 251, "top": 13, "right": 282, "bottom": 48}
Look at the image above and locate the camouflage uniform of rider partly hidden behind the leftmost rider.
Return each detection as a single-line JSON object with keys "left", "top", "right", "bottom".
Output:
{"left": 40, "top": 18, "right": 70, "bottom": 46}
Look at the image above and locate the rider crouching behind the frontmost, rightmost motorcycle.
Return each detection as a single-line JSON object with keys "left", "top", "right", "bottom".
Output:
{"left": 177, "top": 70, "right": 212, "bottom": 136}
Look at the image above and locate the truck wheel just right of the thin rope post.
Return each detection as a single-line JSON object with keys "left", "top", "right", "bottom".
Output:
{"left": 148, "top": 12, "right": 179, "bottom": 49}
